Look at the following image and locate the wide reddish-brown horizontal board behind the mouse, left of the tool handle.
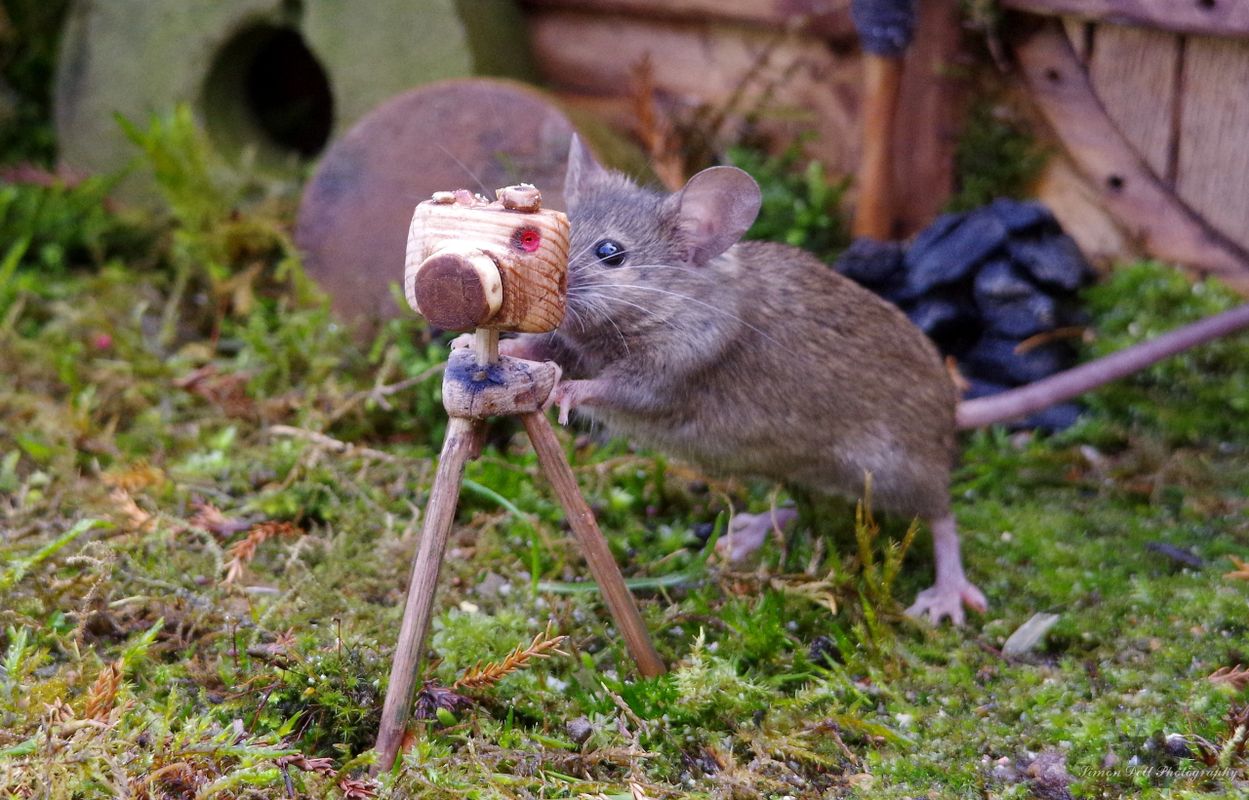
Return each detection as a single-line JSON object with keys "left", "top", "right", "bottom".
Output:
{"left": 530, "top": 9, "right": 862, "bottom": 175}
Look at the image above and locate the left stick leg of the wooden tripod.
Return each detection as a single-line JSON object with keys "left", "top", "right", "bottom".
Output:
{"left": 375, "top": 417, "right": 483, "bottom": 771}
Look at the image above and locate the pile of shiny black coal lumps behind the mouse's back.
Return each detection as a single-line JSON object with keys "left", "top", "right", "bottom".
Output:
{"left": 834, "top": 200, "right": 1093, "bottom": 431}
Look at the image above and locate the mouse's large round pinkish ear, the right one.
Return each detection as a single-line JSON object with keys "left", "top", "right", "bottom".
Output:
{"left": 668, "top": 167, "right": 762, "bottom": 263}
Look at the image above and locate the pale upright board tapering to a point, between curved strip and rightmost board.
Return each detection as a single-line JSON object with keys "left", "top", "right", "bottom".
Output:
{"left": 1088, "top": 25, "right": 1182, "bottom": 181}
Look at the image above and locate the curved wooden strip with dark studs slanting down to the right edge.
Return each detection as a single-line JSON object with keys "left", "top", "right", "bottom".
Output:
{"left": 1013, "top": 21, "right": 1249, "bottom": 293}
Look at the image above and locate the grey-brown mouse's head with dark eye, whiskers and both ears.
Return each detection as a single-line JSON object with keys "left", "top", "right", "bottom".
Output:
{"left": 563, "top": 136, "right": 761, "bottom": 332}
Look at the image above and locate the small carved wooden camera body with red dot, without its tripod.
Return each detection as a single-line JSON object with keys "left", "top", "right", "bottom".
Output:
{"left": 403, "top": 183, "right": 568, "bottom": 333}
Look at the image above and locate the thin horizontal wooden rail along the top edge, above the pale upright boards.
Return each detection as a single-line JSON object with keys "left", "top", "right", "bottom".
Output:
{"left": 999, "top": 0, "right": 1249, "bottom": 37}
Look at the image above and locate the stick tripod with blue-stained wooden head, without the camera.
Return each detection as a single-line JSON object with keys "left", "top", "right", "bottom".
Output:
{"left": 376, "top": 328, "right": 664, "bottom": 770}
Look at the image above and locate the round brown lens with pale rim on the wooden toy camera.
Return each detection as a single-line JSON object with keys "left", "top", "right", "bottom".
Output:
{"left": 408, "top": 247, "right": 503, "bottom": 331}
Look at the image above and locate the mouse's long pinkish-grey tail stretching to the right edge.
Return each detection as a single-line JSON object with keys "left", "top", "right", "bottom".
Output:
{"left": 954, "top": 305, "right": 1249, "bottom": 431}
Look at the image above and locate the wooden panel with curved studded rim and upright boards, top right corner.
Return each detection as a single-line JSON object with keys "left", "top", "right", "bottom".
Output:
{"left": 1003, "top": 0, "right": 1249, "bottom": 293}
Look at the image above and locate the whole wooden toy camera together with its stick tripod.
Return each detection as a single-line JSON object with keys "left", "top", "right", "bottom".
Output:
{"left": 376, "top": 183, "right": 664, "bottom": 769}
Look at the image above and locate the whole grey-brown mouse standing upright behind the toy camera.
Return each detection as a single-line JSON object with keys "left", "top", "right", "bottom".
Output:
{"left": 489, "top": 136, "right": 1249, "bottom": 625}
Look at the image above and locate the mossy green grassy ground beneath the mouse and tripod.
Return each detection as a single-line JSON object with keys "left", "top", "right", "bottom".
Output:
{"left": 0, "top": 115, "right": 1249, "bottom": 800}
